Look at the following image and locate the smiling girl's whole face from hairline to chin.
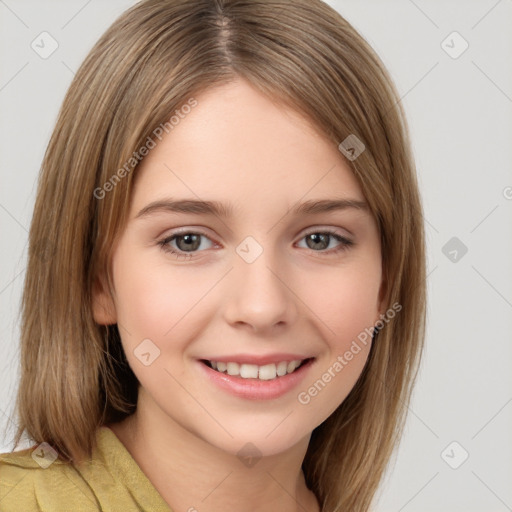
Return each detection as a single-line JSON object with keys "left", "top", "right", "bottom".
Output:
{"left": 95, "top": 80, "right": 382, "bottom": 455}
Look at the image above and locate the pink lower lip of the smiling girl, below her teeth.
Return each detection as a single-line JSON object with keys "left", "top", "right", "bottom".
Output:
{"left": 197, "top": 359, "right": 314, "bottom": 400}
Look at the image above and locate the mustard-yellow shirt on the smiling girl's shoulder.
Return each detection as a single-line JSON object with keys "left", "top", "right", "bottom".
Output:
{"left": 0, "top": 427, "right": 172, "bottom": 512}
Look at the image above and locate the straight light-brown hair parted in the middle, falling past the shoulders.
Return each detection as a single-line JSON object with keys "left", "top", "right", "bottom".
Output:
{"left": 10, "top": 0, "right": 426, "bottom": 512}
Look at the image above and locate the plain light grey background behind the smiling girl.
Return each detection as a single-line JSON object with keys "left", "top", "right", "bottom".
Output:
{"left": 0, "top": 0, "right": 512, "bottom": 512}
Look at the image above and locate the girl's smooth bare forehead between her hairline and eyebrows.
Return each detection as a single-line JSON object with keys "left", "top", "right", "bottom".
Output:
{"left": 133, "top": 79, "right": 364, "bottom": 216}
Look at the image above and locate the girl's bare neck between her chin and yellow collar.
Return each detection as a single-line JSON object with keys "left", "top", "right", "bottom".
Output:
{"left": 109, "top": 397, "right": 319, "bottom": 512}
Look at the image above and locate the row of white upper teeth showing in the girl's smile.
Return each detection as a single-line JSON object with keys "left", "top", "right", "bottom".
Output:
{"left": 200, "top": 357, "right": 314, "bottom": 381}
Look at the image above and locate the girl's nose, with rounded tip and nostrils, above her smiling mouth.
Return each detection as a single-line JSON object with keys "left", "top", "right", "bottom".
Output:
{"left": 224, "top": 245, "right": 298, "bottom": 334}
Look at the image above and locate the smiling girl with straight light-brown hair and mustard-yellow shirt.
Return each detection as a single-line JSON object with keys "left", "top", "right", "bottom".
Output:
{"left": 0, "top": 0, "right": 425, "bottom": 512}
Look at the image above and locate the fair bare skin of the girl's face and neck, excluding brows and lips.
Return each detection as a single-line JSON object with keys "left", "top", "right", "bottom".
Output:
{"left": 94, "top": 79, "right": 384, "bottom": 512}
